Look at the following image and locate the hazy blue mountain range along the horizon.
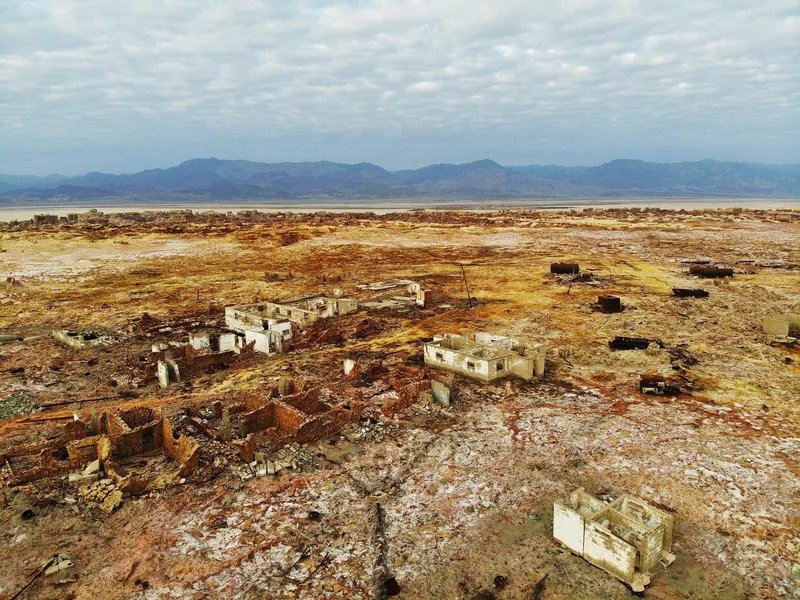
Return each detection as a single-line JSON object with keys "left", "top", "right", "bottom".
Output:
{"left": 0, "top": 158, "right": 800, "bottom": 205}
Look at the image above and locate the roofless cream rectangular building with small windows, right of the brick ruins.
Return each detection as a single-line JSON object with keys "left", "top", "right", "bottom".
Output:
{"left": 424, "top": 332, "right": 546, "bottom": 382}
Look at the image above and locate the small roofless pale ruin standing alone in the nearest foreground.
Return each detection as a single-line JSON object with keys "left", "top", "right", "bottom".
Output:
{"left": 553, "top": 488, "right": 675, "bottom": 592}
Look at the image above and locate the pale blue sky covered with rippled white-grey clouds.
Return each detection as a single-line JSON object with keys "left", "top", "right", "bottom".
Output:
{"left": 0, "top": 0, "right": 800, "bottom": 175}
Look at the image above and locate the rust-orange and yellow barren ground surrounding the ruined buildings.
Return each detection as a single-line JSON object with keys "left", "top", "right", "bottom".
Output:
{"left": 0, "top": 209, "right": 800, "bottom": 600}
